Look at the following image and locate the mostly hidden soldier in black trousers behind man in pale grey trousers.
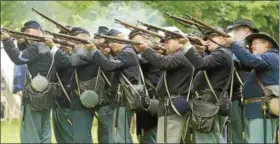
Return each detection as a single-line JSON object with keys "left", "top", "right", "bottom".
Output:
{"left": 129, "top": 30, "right": 162, "bottom": 143}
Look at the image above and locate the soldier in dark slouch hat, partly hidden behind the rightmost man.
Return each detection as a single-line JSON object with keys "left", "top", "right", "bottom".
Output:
{"left": 227, "top": 19, "right": 259, "bottom": 143}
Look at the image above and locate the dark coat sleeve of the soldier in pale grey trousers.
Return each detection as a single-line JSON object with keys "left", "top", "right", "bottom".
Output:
{"left": 142, "top": 48, "right": 187, "bottom": 69}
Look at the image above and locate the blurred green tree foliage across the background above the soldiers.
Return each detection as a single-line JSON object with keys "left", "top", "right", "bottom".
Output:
{"left": 1, "top": 1, "right": 279, "bottom": 40}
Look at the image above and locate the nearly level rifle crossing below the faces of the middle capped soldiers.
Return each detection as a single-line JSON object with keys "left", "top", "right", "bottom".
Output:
{"left": 94, "top": 34, "right": 141, "bottom": 45}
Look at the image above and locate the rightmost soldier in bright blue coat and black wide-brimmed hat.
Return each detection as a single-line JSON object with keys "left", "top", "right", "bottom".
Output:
{"left": 227, "top": 33, "right": 279, "bottom": 143}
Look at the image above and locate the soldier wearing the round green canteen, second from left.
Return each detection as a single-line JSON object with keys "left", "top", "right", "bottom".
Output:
{"left": 70, "top": 27, "right": 99, "bottom": 143}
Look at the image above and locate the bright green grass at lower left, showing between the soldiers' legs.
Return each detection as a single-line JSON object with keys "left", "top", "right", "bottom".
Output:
{"left": 1, "top": 119, "right": 138, "bottom": 143}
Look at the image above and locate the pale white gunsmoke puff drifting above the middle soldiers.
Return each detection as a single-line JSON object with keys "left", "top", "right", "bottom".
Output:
{"left": 82, "top": 1, "right": 166, "bottom": 34}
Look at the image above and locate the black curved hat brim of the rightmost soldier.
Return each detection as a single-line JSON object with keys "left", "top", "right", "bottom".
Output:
{"left": 245, "top": 33, "right": 279, "bottom": 49}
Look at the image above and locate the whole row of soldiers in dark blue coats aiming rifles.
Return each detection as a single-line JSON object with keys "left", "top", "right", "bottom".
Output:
{"left": 1, "top": 19, "right": 279, "bottom": 143}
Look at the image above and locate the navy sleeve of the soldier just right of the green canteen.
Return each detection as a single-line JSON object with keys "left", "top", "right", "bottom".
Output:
{"left": 91, "top": 50, "right": 138, "bottom": 71}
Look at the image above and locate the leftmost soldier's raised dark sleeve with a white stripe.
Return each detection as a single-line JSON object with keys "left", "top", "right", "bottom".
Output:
{"left": 3, "top": 38, "right": 41, "bottom": 65}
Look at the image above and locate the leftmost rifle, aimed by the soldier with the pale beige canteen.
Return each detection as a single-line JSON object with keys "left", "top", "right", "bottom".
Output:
{"left": 1, "top": 28, "right": 74, "bottom": 47}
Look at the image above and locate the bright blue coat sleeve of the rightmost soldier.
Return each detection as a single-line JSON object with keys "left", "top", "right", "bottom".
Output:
{"left": 231, "top": 42, "right": 271, "bottom": 69}
